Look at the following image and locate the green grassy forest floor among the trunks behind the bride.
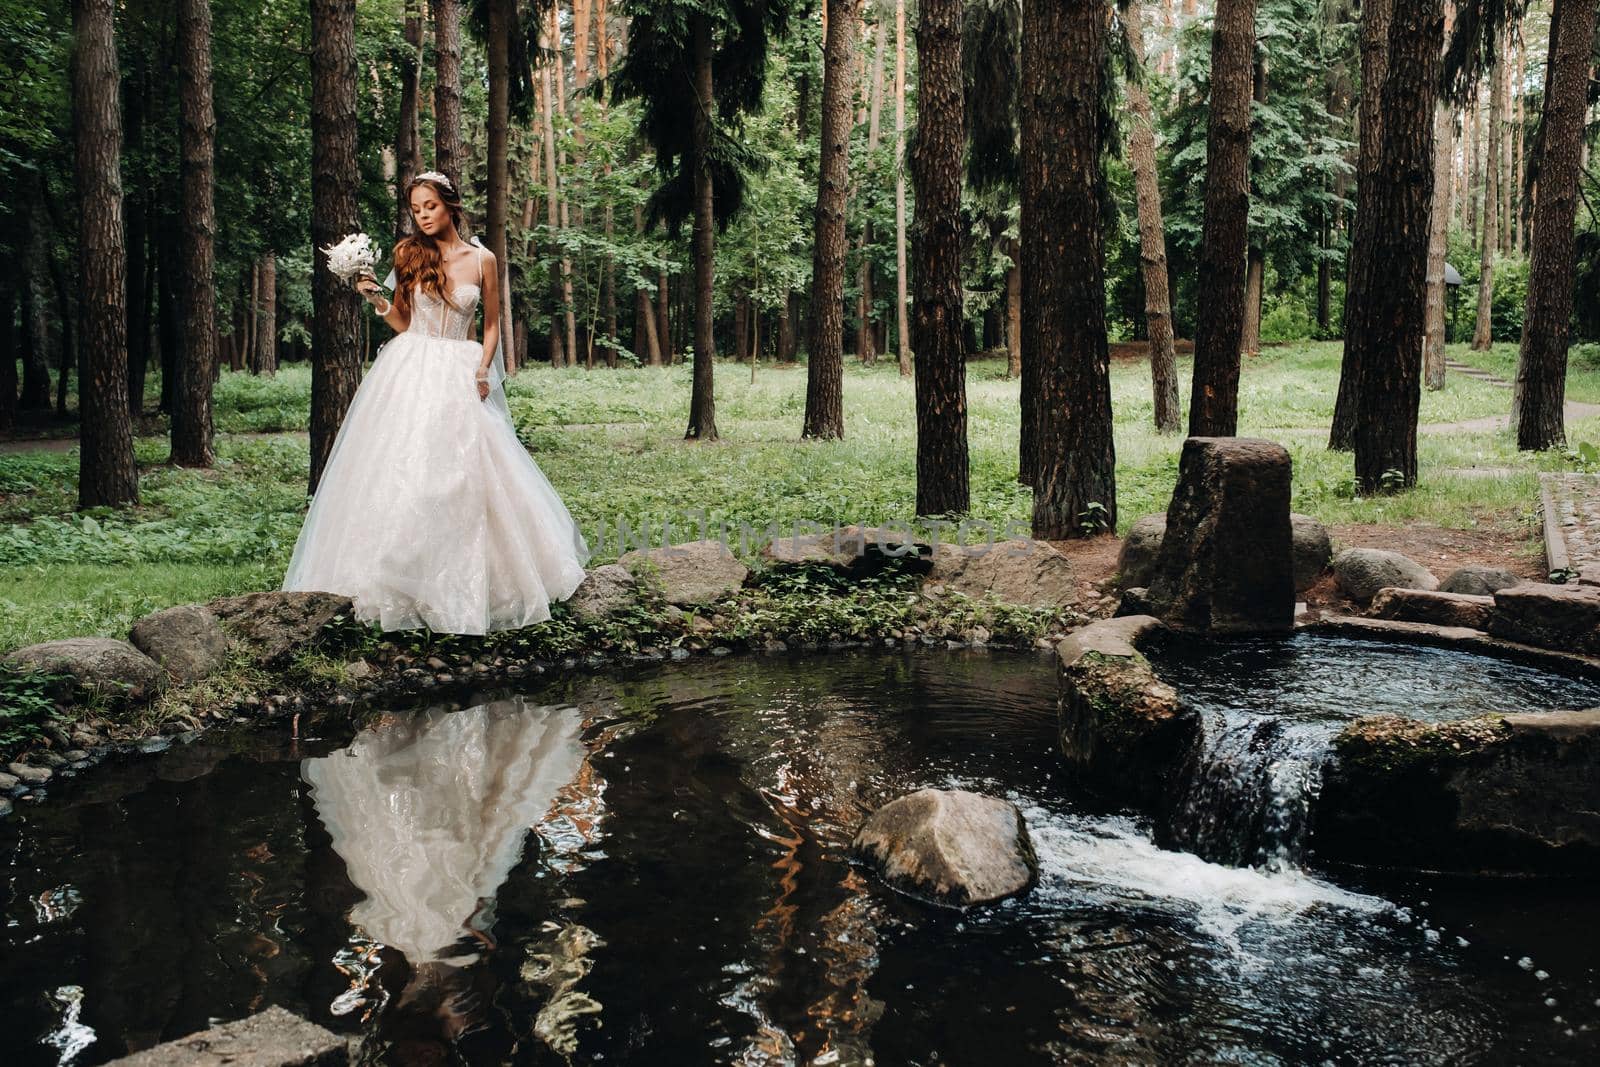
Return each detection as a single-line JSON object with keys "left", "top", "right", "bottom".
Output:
{"left": 0, "top": 342, "right": 1600, "bottom": 649}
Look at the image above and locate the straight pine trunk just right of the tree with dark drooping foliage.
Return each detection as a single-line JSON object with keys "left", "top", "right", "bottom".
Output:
{"left": 800, "top": 0, "right": 864, "bottom": 438}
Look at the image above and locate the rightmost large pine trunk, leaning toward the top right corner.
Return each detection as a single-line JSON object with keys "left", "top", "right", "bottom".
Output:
{"left": 1512, "top": 0, "right": 1595, "bottom": 450}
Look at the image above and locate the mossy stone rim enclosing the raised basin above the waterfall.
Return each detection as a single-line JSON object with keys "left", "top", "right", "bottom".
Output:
{"left": 1056, "top": 616, "right": 1600, "bottom": 875}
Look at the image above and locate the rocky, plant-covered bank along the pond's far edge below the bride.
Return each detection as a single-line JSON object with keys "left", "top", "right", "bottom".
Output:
{"left": 0, "top": 526, "right": 1112, "bottom": 817}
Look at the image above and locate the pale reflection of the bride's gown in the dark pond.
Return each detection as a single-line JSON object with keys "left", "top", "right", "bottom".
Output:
{"left": 301, "top": 697, "right": 586, "bottom": 968}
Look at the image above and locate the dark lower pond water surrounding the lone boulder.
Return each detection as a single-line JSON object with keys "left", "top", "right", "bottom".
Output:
{"left": 0, "top": 653, "right": 1600, "bottom": 1065}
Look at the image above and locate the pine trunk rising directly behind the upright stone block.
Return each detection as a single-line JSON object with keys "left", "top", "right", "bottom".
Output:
{"left": 1184, "top": 0, "right": 1256, "bottom": 437}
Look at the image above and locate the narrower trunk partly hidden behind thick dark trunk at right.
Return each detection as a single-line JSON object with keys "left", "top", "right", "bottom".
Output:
{"left": 1328, "top": 0, "right": 1394, "bottom": 451}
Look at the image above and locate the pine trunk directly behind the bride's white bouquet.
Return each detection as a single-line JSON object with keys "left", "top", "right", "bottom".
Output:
{"left": 310, "top": 0, "right": 361, "bottom": 493}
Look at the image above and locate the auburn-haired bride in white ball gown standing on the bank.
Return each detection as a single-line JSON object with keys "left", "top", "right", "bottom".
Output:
{"left": 283, "top": 171, "right": 589, "bottom": 633}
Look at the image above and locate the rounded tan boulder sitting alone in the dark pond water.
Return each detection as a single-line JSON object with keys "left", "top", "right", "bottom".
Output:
{"left": 854, "top": 789, "right": 1038, "bottom": 907}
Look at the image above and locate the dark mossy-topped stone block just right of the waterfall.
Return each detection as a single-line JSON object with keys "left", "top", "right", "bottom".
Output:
{"left": 1312, "top": 709, "right": 1600, "bottom": 875}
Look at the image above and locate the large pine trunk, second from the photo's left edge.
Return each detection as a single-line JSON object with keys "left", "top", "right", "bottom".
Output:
{"left": 173, "top": 0, "right": 216, "bottom": 467}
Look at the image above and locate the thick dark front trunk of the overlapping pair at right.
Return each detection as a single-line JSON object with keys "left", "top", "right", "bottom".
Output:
{"left": 1347, "top": 0, "right": 1445, "bottom": 493}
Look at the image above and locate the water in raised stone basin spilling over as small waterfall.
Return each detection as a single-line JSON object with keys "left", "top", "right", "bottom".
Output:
{"left": 1144, "top": 632, "right": 1600, "bottom": 870}
